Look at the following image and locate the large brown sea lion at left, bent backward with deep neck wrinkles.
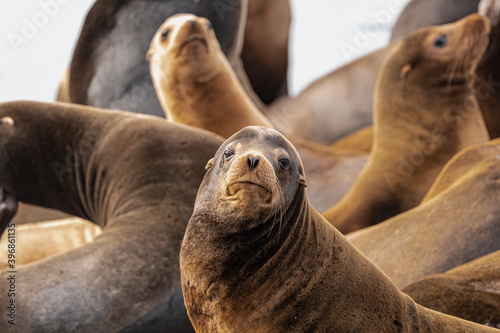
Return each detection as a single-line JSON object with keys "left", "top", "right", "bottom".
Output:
{"left": 0, "top": 102, "right": 222, "bottom": 332}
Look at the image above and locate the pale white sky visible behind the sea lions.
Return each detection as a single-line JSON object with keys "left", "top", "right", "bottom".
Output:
{"left": 0, "top": 0, "right": 409, "bottom": 102}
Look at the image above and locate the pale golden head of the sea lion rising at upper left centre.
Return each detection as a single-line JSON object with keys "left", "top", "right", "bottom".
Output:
{"left": 147, "top": 14, "right": 221, "bottom": 83}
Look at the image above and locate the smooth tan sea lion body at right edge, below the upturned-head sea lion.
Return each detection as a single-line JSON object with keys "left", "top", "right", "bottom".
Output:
{"left": 347, "top": 139, "right": 500, "bottom": 288}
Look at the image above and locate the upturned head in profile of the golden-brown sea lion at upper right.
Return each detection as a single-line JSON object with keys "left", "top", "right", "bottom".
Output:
{"left": 388, "top": 14, "right": 491, "bottom": 89}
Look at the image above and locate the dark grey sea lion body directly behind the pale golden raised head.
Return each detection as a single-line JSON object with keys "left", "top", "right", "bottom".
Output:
{"left": 68, "top": 0, "right": 248, "bottom": 117}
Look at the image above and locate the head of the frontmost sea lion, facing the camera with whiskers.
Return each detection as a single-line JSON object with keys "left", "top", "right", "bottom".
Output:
{"left": 193, "top": 126, "right": 305, "bottom": 230}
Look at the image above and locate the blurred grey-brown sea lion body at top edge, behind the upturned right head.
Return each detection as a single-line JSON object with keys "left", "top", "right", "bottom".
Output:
{"left": 391, "top": 0, "right": 479, "bottom": 41}
